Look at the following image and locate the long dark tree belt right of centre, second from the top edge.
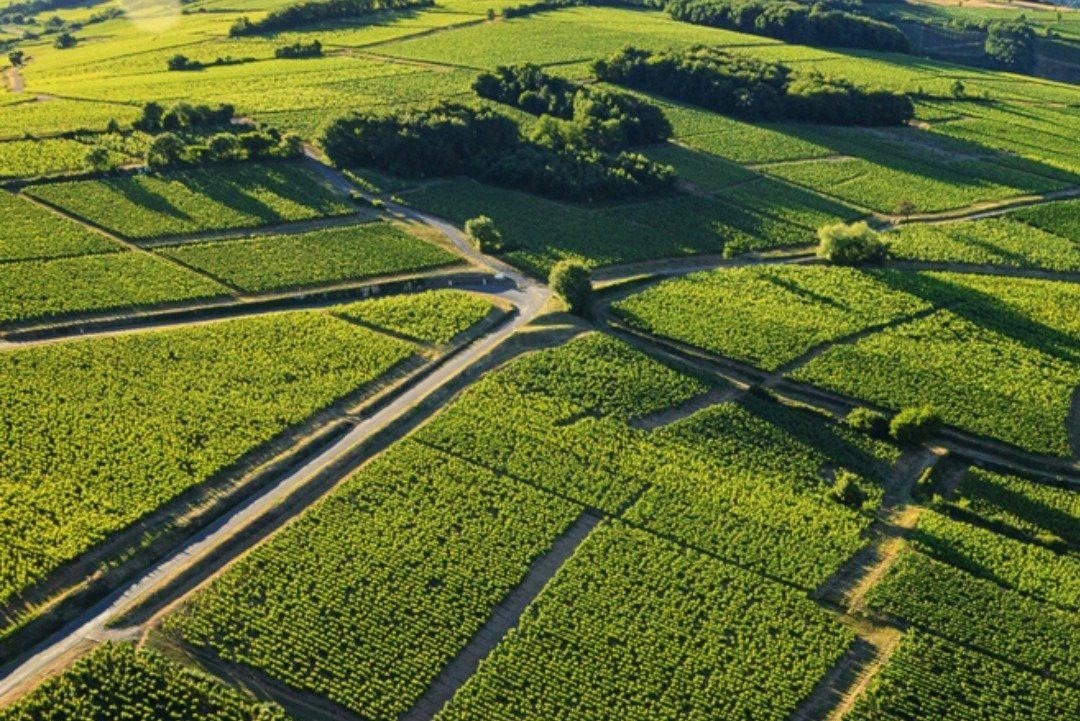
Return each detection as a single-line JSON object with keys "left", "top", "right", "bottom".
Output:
{"left": 593, "top": 46, "right": 915, "bottom": 125}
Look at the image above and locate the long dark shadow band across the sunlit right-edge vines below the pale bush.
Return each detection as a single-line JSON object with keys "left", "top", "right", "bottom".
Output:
{"left": 875, "top": 271, "right": 1080, "bottom": 364}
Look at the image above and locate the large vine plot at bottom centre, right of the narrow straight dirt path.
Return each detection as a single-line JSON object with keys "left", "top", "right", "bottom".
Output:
{"left": 436, "top": 523, "right": 854, "bottom": 721}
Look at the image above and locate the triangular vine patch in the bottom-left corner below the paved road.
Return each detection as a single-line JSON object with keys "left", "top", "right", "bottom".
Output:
{"left": 0, "top": 642, "right": 287, "bottom": 721}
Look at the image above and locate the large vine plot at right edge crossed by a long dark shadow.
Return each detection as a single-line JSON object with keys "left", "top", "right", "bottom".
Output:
{"left": 793, "top": 273, "right": 1080, "bottom": 457}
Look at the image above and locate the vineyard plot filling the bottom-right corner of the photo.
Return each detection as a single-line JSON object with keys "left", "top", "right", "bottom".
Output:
{"left": 845, "top": 630, "right": 1080, "bottom": 721}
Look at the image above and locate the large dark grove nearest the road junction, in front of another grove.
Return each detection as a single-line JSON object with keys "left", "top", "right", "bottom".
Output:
{"left": 323, "top": 101, "right": 675, "bottom": 201}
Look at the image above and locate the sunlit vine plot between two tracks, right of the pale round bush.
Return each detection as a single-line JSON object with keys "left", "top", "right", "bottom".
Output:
{"left": 885, "top": 216, "right": 1080, "bottom": 271}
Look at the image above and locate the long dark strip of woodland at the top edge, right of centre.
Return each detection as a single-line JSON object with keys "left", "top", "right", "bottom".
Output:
{"left": 667, "top": 0, "right": 912, "bottom": 53}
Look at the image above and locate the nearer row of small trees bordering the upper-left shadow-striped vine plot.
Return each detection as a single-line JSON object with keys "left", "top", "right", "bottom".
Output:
{"left": 146, "top": 128, "right": 303, "bottom": 169}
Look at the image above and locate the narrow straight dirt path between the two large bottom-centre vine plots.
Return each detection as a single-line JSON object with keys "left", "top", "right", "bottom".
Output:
{"left": 399, "top": 511, "right": 600, "bottom": 721}
